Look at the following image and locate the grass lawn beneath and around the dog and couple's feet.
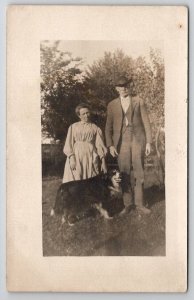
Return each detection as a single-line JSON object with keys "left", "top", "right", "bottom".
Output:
{"left": 42, "top": 169, "right": 165, "bottom": 256}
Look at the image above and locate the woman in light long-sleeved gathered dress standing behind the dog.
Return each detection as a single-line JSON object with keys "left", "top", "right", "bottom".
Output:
{"left": 63, "top": 104, "right": 107, "bottom": 183}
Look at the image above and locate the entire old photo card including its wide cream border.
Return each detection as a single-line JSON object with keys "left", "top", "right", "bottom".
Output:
{"left": 6, "top": 5, "right": 188, "bottom": 292}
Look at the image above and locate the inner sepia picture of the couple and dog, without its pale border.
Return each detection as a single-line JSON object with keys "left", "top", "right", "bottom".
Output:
{"left": 40, "top": 40, "right": 165, "bottom": 256}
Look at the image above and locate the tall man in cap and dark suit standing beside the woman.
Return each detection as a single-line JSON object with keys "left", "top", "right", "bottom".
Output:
{"left": 105, "top": 77, "right": 151, "bottom": 213}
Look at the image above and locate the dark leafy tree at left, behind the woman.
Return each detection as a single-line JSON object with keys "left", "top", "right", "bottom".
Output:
{"left": 40, "top": 41, "right": 87, "bottom": 141}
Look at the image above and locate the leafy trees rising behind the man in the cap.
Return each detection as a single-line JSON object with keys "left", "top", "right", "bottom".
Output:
{"left": 87, "top": 49, "right": 164, "bottom": 138}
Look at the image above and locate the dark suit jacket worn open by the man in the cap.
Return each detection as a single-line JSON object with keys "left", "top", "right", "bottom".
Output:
{"left": 105, "top": 96, "right": 152, "bottom": 150}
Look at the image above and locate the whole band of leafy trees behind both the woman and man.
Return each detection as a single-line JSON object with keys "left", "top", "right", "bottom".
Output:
{"left": 40, "top": 41, "right": 164, "bottom": 143}
